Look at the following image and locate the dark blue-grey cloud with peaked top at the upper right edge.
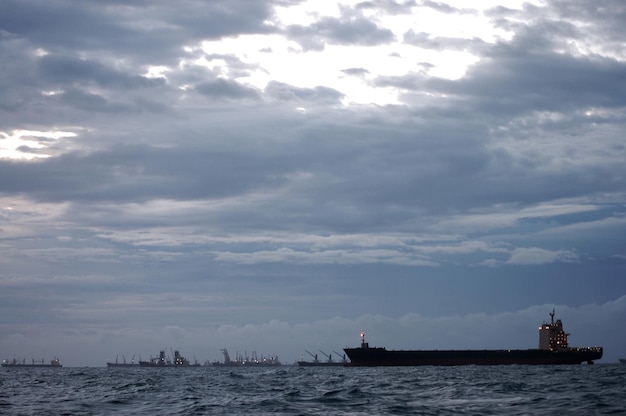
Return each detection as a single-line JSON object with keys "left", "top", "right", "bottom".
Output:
{"left": 377, "top": 29, "right": 626, "bottom": 116}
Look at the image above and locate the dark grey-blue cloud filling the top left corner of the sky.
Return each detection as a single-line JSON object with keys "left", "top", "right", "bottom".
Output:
{"left": 0, "top": 0, "right": 271, "bottom": 64}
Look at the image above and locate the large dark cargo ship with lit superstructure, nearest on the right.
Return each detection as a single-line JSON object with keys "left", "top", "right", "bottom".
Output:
{"left": 344, "top": 311, "right": 603, "bottom": 367}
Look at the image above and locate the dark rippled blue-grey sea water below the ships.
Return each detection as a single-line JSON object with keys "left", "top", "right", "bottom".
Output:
{"left": 0, "top": 364, "right": 626, "bottom": 415}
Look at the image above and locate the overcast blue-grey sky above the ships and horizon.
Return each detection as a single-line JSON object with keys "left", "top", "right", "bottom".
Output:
{"left": 0, "top": 0, "right": 626, "bottom": 366}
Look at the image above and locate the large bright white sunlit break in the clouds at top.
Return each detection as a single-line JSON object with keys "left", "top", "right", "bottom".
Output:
{"left": 195, "top": 2, "right": 507, "bottom": 105}
